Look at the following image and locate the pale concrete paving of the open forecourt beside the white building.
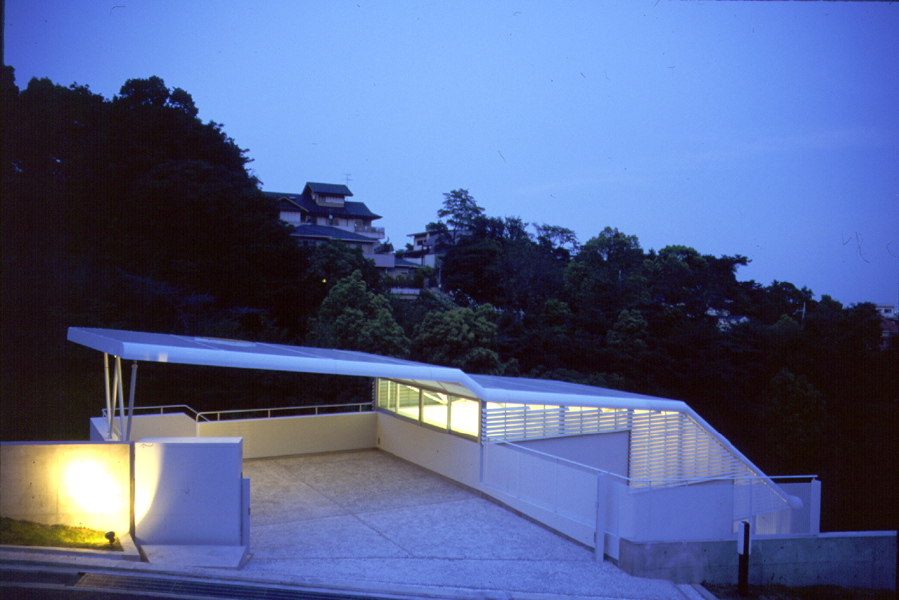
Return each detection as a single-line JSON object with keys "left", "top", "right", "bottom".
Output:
{"left": 240, "top": 450, "right": 708, "bottom": 600}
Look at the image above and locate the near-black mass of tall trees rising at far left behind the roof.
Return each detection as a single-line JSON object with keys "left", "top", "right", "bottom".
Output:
{"left": 0, "top": 74, "right": 305, "bottom": 439}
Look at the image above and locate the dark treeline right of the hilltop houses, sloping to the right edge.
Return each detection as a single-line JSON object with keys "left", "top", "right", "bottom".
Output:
{"left": 416, "top": 190, "right": 899, "bottom": 530}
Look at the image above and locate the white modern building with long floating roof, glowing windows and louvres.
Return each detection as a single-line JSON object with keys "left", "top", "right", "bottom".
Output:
{"left": 68, "top": 328, "right": 820, "bottom": 576}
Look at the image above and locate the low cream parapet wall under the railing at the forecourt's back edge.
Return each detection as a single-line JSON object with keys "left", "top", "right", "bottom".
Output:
{"left": 197, "top": 412, "right": 376, "bottom": 458}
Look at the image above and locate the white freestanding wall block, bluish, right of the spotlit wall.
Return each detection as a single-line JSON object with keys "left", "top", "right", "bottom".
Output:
{"left": 134, "top": 438, "right": 244, "bottom": 546}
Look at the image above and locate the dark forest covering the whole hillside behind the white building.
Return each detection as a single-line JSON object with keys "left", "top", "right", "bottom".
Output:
{"left": 0, "top": 67, "right": 899, "bottom": 530}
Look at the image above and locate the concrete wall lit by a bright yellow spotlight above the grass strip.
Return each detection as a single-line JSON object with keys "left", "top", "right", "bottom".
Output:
{"left": 0, "top": 442, "right": 131, "bottom": 532}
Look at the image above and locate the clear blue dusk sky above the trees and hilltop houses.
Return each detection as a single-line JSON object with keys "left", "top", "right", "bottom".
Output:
{"left": 4, "top": 0, "right": 899, "bottom": 304}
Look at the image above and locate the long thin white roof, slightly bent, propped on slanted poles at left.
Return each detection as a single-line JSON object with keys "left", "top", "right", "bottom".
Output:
{"left": 68, "top": 327, "right": 689, "bottom": 411}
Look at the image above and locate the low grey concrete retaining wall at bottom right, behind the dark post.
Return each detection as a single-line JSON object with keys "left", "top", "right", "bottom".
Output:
{"left": 618, "top": 531, "right": 896, "bottom": 590}
